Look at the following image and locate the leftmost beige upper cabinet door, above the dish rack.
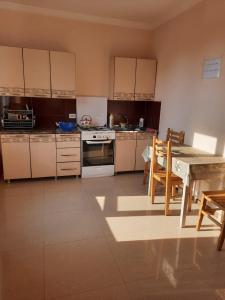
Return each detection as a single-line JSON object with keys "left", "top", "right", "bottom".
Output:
{"left": 0, "top": 46, "right": 24, "bottom": 96}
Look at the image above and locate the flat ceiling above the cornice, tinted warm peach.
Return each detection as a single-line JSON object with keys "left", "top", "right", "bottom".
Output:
{"left": 0, "top": 0, "right": 202, "bottom": 29}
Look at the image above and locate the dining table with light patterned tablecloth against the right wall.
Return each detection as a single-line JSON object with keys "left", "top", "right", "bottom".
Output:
{"left": 145, "top": 145, "right": 225, "bottom": 227}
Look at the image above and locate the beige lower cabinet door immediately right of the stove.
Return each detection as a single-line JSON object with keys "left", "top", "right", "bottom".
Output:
{"left": 115, "top": 140, "right": 136, "bottom": 172}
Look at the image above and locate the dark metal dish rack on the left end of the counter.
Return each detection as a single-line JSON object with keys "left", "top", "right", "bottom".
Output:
{"left": 1, "top": 108, "right": 35, "bottom": 129}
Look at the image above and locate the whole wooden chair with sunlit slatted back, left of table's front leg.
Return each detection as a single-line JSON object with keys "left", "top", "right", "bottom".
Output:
{"left": 150, "top": 137, "right": 182, "bottom": 215}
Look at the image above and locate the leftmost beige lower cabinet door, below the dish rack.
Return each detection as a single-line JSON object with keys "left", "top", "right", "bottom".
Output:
{"left": 1, "top": 134, "right": 31, "bottom": 180}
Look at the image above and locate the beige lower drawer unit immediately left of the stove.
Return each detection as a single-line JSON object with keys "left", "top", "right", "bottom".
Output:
{"left": 56, "top": 133, "right": 81, "bottom": 176}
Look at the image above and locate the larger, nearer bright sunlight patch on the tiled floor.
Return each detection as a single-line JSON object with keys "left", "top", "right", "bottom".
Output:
{"left": 106, "top": 215, "right": 219, "bottom": 242}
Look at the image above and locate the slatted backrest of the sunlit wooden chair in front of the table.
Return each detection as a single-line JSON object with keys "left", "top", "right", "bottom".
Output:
{"left": 151, "top": 136, "right": 172, "bottom": 177}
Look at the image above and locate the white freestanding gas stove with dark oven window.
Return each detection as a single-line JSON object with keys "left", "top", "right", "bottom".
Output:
{"left": 81, "top": 127, "right": 115, "bottom": 178}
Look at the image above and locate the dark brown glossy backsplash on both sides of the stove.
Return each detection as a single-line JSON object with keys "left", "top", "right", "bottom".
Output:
{"left": 0, "top": 97, "right": 161, "bottom": 130}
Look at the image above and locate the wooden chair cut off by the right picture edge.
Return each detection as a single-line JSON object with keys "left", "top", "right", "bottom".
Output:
{"left": 196, "top": 190, "right": 225, "bottom": 251}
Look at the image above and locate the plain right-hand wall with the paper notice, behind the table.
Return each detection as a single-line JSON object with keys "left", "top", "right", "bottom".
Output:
{"left": 153, "top": 0, "right": 225, "bottom": 153}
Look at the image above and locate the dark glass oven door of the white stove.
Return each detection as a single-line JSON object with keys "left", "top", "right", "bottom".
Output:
{"left": 83, "top": 140, "right": 114, "bottom": 167}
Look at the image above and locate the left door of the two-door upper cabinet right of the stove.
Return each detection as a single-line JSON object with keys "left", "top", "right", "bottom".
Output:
{"left": 113, "top": 57, "right": 136, "bottom": 100}
